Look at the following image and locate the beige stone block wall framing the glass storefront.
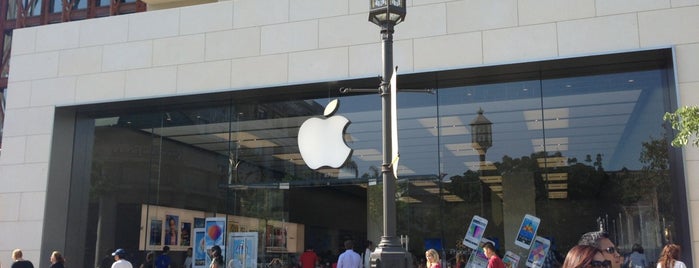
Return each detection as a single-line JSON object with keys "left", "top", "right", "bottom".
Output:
{"left": 0, "top": 0, "right": 699, "bottom": 267}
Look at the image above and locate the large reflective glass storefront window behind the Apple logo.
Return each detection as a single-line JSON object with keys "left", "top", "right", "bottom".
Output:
{"left": 58, "top": 50, "right": 689, "bottom": 267}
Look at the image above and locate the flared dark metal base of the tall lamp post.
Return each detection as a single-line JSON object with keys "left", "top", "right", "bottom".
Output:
{"left": 371, "top": 236, "right": 413, "bottom": 268}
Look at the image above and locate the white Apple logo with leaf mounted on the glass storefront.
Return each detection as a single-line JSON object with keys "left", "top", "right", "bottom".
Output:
{"left": 298, "top": 99, "right": 352, "bottom": 169}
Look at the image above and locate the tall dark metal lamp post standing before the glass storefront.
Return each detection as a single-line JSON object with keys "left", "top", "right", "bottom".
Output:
{"left": 369, "top": 0, "right": 410, "bottom": 268}
